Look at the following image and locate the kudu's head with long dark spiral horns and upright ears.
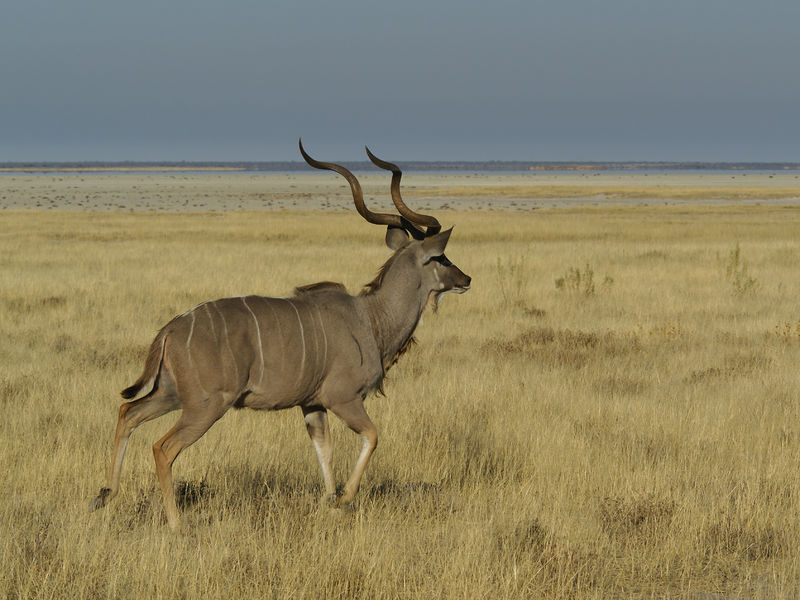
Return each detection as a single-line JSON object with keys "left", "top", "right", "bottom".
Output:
{"left": 300, "top": 140, "right": 472, "bottom": 310}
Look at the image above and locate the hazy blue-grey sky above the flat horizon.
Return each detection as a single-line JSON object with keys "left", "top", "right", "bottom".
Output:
{"left": 0, "top": 0, "right": 800, "bottom": 161}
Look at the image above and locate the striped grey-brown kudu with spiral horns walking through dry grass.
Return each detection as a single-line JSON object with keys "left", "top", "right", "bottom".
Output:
{"left": 89, "top": 140, "right": 471, "bottom": 529}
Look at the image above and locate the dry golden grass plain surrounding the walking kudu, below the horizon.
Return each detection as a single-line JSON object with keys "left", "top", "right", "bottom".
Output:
{"left": 0, "top": 175, "right": 800, "bottom": 600}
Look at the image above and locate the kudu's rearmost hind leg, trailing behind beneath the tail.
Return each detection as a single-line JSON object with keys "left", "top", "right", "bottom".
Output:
{"left": 89, "top": 392, "right": 180, "bottom": 512}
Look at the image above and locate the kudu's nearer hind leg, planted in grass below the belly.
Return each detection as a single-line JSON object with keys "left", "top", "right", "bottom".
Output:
{"left": 153, "top": 402, "right": 225, "bottom": 529}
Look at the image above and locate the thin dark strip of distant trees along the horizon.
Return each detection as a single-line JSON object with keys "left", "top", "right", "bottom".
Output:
{"left": 0, "top": 160, "right": 800, "bottom": 172}
